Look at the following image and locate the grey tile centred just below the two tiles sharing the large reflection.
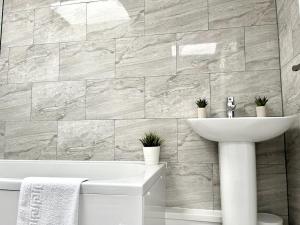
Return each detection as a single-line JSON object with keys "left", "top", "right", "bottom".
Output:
{"left": 60, "top": 41, "right": 115, "bottom": 80}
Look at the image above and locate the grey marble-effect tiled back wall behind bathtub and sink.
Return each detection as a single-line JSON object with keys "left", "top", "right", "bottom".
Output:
{"left": 0, "top": 0, "right": 287, "bottom": 216}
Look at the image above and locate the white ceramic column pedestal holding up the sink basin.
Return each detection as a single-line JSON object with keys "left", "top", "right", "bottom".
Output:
{"left": 219, "top": 142, "right": 257, "bottom": 225}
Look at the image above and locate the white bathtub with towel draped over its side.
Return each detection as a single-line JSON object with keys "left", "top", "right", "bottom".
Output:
{"left": 0, "top": 160, "right": 165, "bottom": 225}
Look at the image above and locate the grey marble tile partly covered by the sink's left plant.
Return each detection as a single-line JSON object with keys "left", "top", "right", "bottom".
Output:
{"left": 145, "top": 74, "right": 210, "bottom": 118}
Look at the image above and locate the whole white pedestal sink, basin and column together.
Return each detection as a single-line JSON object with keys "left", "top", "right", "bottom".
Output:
{"left": 188, "top": 116, "right": 296, "bottom": 225}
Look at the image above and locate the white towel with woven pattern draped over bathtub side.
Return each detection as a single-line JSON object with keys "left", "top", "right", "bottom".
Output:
{"left": 17, "top": 177, "right": 86, "bottom": 225}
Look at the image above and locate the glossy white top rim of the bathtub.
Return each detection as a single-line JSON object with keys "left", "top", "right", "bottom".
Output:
{"left": 0, "top": 159, "right": 167, "bottom": 196}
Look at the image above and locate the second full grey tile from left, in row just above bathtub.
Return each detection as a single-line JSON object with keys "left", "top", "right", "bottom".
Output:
{"left": 57, "top": 120, "right": 114, "bottom": 160}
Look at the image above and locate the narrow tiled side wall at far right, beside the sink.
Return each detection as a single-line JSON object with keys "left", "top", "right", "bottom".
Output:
{"left": 277, "top": 0, "right": 300, "bottom": 225}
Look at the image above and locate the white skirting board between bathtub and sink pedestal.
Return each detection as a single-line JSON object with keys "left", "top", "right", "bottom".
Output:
{"left": 165, "top": 207, "right": 222, "bottom": 225}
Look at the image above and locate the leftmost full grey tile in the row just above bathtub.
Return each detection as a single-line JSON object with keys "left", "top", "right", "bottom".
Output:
{"left": 4, "top": 121, "right": 57, "bottom": 160}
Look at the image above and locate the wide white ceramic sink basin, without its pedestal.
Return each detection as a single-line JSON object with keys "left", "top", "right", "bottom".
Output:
{"left": 188, "top": 116, "right": 296, "bottom": 142}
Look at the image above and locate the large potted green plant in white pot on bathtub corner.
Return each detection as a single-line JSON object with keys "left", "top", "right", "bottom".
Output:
{"left": 140, "top": 132, "right": 163, "bottom": 165}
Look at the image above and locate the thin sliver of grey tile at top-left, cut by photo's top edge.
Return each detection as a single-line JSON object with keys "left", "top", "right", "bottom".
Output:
{"left": 4, "top": 0, "right": 60, "bottom": 12}
